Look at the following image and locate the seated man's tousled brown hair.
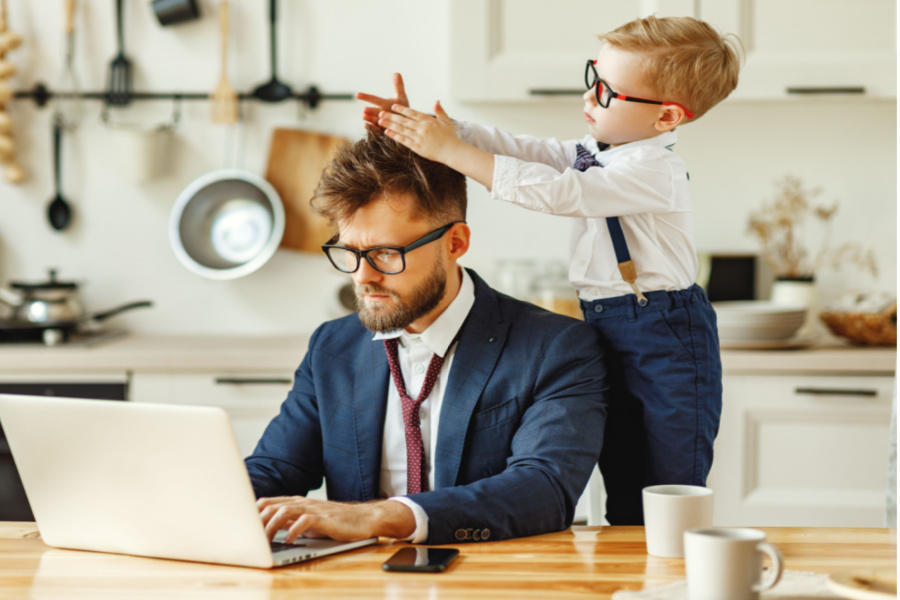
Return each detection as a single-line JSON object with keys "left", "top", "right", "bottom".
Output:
{"left": 310, "top": 131, "right": 466, "bottom": 229}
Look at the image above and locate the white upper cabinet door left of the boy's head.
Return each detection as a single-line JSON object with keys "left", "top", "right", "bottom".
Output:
{"left": 450, "top": 0, "right": 694, "bottom": 101}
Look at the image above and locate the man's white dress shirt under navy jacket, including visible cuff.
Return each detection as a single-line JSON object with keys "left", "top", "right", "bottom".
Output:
{"left": 372, "top": 269, "right": 475, "bottom": 543}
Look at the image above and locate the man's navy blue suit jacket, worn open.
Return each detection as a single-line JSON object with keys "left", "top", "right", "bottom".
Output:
{"left": 246, "top": 271, "right": 606, "bottom": 544}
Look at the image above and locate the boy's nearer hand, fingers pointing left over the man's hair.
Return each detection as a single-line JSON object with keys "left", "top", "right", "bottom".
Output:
{"left": 378, "top": 101, "right": 463, "bottom": 164}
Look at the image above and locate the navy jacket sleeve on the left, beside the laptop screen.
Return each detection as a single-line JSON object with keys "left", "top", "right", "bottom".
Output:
{"left": 244, "top": 328, "right": 324, "bottom": 498}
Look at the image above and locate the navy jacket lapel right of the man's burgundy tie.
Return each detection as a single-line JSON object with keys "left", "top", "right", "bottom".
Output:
{"left": 433, "top": 271, "right": 509, "bottom": 489}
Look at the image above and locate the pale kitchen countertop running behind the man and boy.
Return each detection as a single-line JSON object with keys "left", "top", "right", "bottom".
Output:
{"left": 0, "top": 334, "right": 897, "bottom": 374}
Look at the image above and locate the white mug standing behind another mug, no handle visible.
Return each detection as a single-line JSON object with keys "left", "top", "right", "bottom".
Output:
{"left": 643, "top": 485, "right": 713, "bottom": 558}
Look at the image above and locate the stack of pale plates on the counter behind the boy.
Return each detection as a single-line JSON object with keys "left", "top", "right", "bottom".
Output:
{"left": 713, "top": 300, "right": 806, "bottom": 348}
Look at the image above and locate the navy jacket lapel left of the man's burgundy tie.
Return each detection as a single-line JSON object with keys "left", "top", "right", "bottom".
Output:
{"left": 353, "top": 339, "right": 389, "bottom": 500}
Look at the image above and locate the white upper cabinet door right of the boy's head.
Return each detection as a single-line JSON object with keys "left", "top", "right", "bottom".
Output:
{"left": 698, "top": 0, "right": 897, "bottom": 99}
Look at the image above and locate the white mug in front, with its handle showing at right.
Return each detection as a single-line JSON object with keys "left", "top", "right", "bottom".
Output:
{"left": 684, "top": 528, "right": 784, "bottom": 600}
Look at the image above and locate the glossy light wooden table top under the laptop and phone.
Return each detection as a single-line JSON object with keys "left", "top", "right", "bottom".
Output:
{"left": 0, "top": 523, "right": 897, "bottom": 600}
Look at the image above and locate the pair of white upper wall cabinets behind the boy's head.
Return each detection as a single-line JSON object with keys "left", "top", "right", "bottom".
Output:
{"left": 450, "top": 0, "right": 897, "bottom": 101}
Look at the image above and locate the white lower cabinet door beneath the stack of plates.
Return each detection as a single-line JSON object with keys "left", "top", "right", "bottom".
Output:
{"left": 708, "top": 374, "right": 894, "bottom": 527}
